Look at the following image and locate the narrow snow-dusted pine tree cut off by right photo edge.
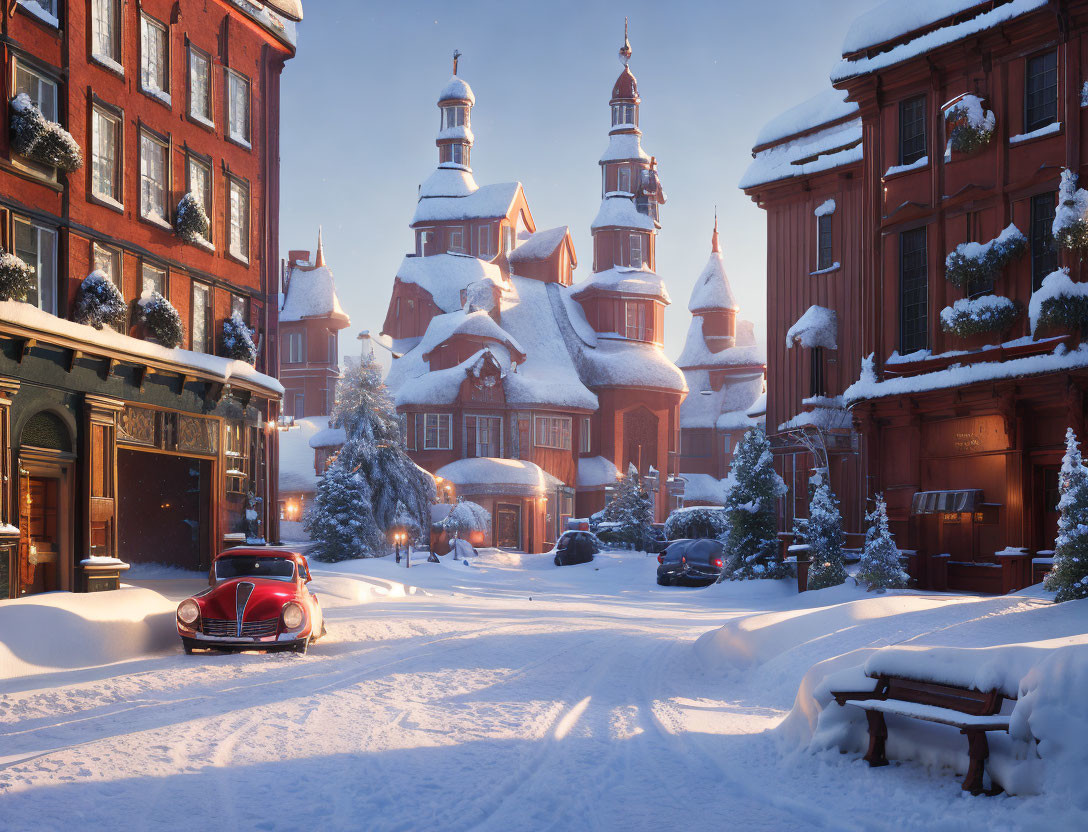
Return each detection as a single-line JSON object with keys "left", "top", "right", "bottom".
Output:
{"left": 1044, "top": 427, "right": 1088, "bottom": 603}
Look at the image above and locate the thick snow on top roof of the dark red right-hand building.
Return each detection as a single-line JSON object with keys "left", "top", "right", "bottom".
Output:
{"left": 831, "top": 0, "right": 1048, "bottom": 83}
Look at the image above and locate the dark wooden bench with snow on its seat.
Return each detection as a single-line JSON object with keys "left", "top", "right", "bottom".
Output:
{"left": 831, "top": 675, "right": 1010, "bottom": 794}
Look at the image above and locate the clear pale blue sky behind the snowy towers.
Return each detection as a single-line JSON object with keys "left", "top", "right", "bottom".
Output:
{"left": 280, "top": 0, "right": 876, "bottom": 358}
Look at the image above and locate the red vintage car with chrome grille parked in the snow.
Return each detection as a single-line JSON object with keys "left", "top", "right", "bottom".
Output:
{"left": 177, "top": 547, "right": 325, "bottom": 653}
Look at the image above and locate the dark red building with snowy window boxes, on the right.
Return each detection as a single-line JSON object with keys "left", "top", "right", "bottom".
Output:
{"left": 744, "top": 0, "right": 1088, "bottom": 592}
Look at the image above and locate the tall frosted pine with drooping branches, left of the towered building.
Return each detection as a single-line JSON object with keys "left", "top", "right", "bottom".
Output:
{"left": 329, "top": 351, "right": 435, "bottom": 542}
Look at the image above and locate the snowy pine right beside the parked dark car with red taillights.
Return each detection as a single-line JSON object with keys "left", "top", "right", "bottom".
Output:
{"left": 721, "top": 427, "right": 786, "bottom": 581}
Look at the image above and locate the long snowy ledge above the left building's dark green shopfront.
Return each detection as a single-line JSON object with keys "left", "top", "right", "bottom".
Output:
{"left": 0, "top": 300, "right": 283, "bottom": 398}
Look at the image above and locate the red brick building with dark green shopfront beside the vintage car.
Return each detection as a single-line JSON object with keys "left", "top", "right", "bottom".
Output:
{"left": 0, "top": 0, "right": 299, "bottom": 595}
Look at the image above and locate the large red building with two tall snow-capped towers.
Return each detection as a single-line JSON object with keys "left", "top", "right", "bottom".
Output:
{"left": 383, "top": 34, "right": 687, "bottom": 551}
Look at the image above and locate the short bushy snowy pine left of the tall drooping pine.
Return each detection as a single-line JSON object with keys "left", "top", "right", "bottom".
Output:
{"left": 305, "top": 457, "right": 383, "bottom": 561}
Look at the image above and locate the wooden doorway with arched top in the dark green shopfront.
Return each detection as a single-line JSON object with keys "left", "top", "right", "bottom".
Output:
{"left": 17, "top": 410, "right": 75, "bottom": 595}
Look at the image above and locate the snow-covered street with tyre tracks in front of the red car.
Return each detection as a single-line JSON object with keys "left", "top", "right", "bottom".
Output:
{"left": 0, "top": 551, "right": 1062, "bottom": 830}
